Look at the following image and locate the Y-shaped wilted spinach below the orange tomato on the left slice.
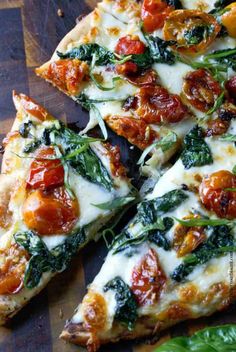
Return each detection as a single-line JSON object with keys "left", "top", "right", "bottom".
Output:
{"left": 14, "top": 228, "right": 86, "bottom": 289}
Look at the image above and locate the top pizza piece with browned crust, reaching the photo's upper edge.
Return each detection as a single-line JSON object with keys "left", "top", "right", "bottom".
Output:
{"left": 36, "top": 0, "right": 236, "bottom": 174}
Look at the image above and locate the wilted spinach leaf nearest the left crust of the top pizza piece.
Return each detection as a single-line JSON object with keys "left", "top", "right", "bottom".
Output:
{"left": 57, "top": 43, "right": 115, "bottom": 66}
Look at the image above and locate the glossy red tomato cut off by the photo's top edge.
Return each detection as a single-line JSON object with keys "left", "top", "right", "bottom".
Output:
{"left": 141, "top": 0, "right": 175, "bottom": 33}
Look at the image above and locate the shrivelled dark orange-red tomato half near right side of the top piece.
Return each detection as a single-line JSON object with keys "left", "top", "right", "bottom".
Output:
{"left": 183, "top": 69, "right": 222, "bottom": 112}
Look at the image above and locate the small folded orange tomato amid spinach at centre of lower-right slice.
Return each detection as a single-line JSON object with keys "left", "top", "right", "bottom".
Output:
{"left": 173, "top": 217, "right": 206, "bottom": 257}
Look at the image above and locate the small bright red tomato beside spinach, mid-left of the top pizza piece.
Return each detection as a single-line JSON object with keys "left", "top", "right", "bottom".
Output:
{"left": 115, "top": 35, "right": 146, "bottom": 55}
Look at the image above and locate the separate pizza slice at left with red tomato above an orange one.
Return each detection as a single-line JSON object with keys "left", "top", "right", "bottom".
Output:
{"left": 0, "top": 93, "right": 133, "bottom": 323}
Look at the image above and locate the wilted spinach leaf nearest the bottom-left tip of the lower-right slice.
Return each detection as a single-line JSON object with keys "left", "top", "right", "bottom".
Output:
{"left": 103, "top": 276, "right": 138, "bottom": 330}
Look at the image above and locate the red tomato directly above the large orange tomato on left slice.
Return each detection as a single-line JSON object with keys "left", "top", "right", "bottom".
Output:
{"left": 26, "top": 147, "right": 64, "bottom": 190}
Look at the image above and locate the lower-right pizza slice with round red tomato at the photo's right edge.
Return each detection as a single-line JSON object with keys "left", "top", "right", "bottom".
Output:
{"left": 61, "top": 119, "right": 236, "bottom": 352}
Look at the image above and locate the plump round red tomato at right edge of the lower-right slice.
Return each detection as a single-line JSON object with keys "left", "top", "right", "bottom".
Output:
{"left": 199, "top": 170, "right": 236, "bottom": 219}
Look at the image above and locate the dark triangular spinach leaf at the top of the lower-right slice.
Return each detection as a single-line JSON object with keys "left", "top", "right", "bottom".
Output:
{"left": 180, "top": 125, "right": 213, "bottom": 169}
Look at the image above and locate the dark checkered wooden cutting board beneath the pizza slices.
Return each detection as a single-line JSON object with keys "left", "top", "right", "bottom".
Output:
{"left": 0, "top": 0, "right": 236, "bottom": 352}
